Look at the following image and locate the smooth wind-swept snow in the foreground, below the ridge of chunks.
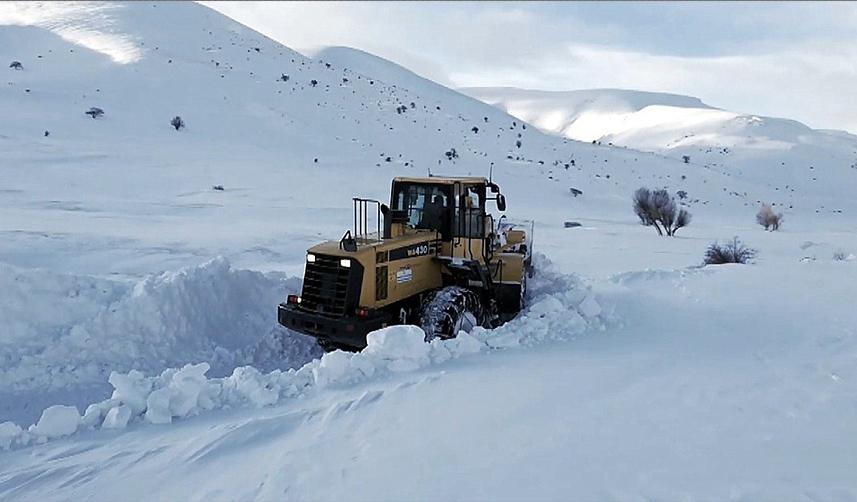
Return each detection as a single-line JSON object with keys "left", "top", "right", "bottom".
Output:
{"left": 0, "top": 256, "right": 857, "bottom": 500}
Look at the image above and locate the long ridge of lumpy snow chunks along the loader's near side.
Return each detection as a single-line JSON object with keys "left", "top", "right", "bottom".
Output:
{"left": 0, "top": 256, "right": 602, "bottom": 449}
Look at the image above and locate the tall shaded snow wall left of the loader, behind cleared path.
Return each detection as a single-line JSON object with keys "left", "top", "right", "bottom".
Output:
{"left": 0, "top": 259, "right": 318, "bottom": 400}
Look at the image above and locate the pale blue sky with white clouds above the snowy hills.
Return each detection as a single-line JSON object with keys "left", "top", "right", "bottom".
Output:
{"left": 202, "top": 2, "right": 857, "bottom": 133}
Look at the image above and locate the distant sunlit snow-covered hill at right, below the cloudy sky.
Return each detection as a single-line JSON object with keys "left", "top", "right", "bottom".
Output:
{"left": 462, "top": 87, "right": 857, "bottom": 204}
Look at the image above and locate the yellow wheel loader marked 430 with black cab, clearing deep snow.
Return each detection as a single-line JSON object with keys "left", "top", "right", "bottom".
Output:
{"left": 278, "top": 176, "right": 533, "bottom": 351}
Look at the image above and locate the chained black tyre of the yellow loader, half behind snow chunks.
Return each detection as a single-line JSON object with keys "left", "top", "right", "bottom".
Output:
{"left": 420, "top": 286, "right": 485, "bottom": 341}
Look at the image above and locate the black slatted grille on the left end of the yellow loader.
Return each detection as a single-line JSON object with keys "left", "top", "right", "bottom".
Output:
{"left": 301, "top": 255, "right": 351, "bottom": 316}
